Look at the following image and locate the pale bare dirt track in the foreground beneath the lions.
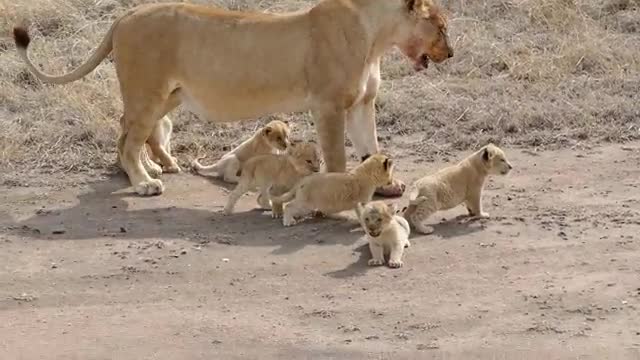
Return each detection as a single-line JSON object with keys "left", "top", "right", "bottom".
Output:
{"left": 0, "top": 143, "right": 640, "bottom": 359}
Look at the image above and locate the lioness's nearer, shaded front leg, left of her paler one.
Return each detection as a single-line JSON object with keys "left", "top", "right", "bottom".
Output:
{"left": 313, "top": 108, "right": 347, "bottom": 172}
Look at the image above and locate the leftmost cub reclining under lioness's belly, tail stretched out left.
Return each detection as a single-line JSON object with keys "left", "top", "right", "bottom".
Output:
{"left": 192, "top": 120, "right": 289, "bottom": 183}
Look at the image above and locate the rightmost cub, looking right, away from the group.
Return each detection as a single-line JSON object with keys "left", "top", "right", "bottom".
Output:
{"left": 404, "top": 144, "right": 513, "bottom": 234}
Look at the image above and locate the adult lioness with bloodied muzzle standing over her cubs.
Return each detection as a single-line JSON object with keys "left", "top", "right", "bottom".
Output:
{"left": 13, "top": 0, "right": 453, "bottom": 195}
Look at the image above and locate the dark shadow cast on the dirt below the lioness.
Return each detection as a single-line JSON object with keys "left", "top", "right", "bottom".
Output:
{"left": 0, "top": 173, "right": 358, "bottom": 254}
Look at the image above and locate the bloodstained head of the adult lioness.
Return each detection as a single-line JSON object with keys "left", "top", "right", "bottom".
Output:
{"left": 398, "top": 0, "right": 453, "bottom": 71}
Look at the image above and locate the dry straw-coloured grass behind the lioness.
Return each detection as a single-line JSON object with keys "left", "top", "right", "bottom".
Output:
{"left": 0, "top": 0, "right": 640, "bottom": 183}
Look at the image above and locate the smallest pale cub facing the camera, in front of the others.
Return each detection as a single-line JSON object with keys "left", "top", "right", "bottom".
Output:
{"left": 356, "top": 201, "right": 411, "bottom": 268}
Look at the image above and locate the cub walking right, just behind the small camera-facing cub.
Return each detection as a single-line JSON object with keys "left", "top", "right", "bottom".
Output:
{"left": 271, "top": 154, "right": 394, "bottom": 226}
